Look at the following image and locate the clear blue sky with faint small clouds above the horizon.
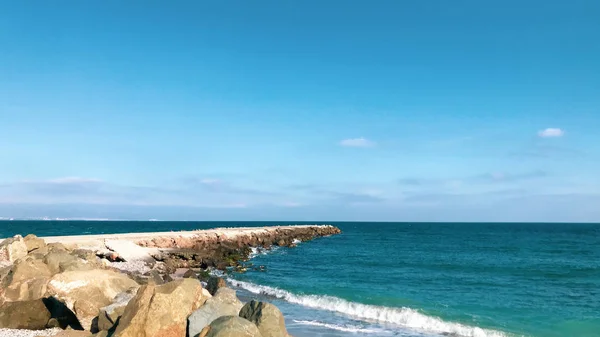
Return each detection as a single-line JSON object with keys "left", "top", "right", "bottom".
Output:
{"left": 0, "top": 0, "right": 600, "bottom": 222}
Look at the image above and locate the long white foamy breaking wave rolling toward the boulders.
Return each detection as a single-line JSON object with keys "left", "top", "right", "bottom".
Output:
{"left": 229, "top": 279, "right": 511, "bottom": 337}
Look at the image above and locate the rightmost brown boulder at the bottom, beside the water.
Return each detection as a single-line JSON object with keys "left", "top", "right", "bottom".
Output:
{"left": 240, "top": 301, "right": 288, "bottom": 337}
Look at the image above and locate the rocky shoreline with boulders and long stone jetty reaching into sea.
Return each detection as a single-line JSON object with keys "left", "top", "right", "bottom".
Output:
{"left": 0, "top": 225, "right": 340, "bottom": 337}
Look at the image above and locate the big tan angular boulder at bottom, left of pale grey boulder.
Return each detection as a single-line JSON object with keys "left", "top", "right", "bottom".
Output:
{"left": 114, "top": 279, "right": 207, "bottom": 337}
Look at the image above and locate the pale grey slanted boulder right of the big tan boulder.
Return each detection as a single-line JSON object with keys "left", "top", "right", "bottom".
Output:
{"left": 188, "top": 288, "right": 244, "bottom": 337}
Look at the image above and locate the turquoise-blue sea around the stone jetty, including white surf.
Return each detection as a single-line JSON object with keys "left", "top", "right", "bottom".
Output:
{"left": 0, "top": 221, "right": 600, "bottom": 337}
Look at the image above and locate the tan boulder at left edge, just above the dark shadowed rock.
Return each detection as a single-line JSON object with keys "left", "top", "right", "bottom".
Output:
{"left": 0, "top": 256, "right": 52, "bottom": 302}
